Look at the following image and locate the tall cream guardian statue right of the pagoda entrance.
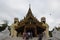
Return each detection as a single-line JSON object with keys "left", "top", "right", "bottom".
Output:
{"left": 41, "top": 17, "right": 49, "bottom": 40}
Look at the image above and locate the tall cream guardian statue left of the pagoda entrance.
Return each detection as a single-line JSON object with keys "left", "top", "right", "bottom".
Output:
{"left": 10, "top": 18, "right": 19, "bottom": 37}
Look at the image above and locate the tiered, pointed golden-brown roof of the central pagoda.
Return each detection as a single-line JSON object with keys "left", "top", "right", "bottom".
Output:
{"left": 16, "top": 7, "right": 45, "bottom": 29}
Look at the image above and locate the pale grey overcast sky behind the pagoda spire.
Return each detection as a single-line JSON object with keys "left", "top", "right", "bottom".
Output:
{"left": 0, "top": 0, "right": 60, "bottom": 30}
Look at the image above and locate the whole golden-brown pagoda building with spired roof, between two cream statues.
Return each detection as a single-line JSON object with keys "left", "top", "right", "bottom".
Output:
{"left": 16, "top": 7, "right": 46, "bottom": 37}
